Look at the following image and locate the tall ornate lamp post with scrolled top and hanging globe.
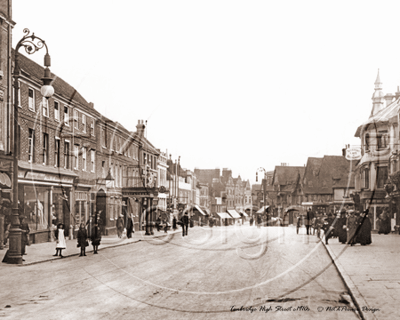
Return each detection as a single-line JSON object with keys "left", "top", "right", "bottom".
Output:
{"left": 6, "top": 29, "right": 54, "bottom": 264}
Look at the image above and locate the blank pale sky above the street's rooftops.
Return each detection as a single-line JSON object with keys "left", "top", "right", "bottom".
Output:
{"left": 13, "top": 0, "right": 400, "bottom": 184}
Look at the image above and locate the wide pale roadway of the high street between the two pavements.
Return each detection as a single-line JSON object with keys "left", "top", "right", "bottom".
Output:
{"left": 0, "top": 226, "right": 358, "bottom": 319}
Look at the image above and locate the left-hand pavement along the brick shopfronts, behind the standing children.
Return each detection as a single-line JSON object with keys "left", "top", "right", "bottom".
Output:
{"left": 0, "top": 227, "right": 182, "bottom": 268}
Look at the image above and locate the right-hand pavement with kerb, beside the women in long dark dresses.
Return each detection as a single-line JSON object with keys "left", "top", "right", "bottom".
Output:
{"left": 323, "top": 234, "right": 400, "bottom": 320}
